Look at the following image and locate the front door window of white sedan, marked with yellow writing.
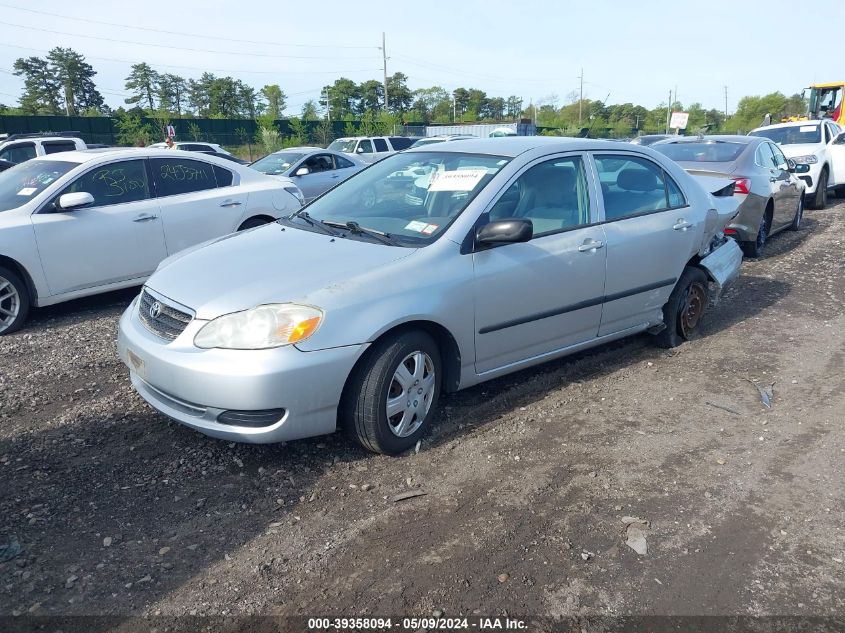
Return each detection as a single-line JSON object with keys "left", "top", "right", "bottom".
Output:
{"left": 57, "top": 159, "right": 150, "bottom": 207}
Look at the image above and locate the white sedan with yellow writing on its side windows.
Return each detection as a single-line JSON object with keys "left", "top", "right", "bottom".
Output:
{"left": 0, "top": 148, "right": 304, "bottom": 335}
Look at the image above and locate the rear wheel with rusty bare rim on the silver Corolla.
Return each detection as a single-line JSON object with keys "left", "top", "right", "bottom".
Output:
{"left": 655, "top": 266, "right": 709, "bottom": 348}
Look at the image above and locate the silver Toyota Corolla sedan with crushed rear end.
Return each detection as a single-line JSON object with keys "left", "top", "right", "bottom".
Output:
{"left": 118, "top": 137, "right": 742, "bottom": 454}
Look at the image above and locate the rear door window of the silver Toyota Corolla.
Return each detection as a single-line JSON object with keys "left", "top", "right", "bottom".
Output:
{"left": 595, "top": 154, "right": 686, "bottom": 222}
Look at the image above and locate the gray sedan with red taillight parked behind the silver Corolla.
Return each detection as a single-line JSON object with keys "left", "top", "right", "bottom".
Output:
{"left": 652, "top": 136, "right": 806, "bottom": 257}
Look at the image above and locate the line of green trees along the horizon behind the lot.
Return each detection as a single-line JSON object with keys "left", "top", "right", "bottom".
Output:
{"left": 0, "top": 47, "right": 807, "bottom": 136}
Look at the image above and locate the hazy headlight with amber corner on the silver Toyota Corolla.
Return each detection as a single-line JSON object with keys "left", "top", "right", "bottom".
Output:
{"left": 194, "top": 303, "right": 323, "bottom": 349}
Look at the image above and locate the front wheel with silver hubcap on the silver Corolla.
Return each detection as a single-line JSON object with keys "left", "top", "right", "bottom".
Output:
{"left": 340, "top": 330, "right": 442, "bottom": 455}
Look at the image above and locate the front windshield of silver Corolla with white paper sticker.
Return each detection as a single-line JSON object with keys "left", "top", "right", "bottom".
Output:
{"left": 296, "top": 150, "right": 509, "bottom": 246}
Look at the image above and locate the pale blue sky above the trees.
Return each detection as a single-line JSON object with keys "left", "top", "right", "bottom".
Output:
{"left": 0, "top": 0, "right": 845, "bottom": 114}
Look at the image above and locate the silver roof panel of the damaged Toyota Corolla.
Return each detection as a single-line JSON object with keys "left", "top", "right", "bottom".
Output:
{"left": 404, "top": 136, "right": 640, "bottom": 158}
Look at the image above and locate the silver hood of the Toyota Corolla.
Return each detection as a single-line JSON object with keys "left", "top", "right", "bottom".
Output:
{"left": 146, "top": 223, "right": 416, "bottom": 319}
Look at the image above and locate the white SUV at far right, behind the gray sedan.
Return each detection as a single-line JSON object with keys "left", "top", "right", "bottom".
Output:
{"left": 749, "top": 119, "right": 845, "bottom": 209}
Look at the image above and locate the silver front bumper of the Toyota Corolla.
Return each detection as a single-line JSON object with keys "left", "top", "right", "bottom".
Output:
{"left": 117, "top": 300, "right": 367, "bottom": 444}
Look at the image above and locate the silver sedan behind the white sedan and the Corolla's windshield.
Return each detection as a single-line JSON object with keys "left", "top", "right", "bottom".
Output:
{"left": 250, "top": 147, "right": 368, "bottom": 202}
